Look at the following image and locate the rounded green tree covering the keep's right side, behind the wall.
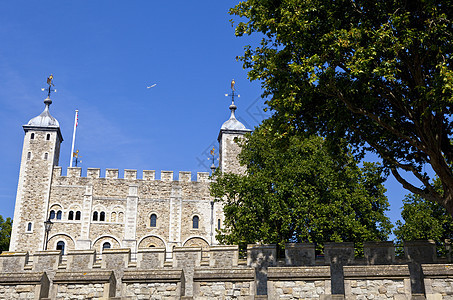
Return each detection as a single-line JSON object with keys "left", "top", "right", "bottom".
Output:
{"left": 211, "top": 125, "right": 391, "bottom": 250}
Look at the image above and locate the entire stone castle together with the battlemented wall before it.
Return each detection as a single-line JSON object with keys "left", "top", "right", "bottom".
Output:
{"left": 0, "top": 84, "right": 453, "bottom": 300}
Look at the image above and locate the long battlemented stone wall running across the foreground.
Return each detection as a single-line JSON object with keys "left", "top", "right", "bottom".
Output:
{"left": 0, "top": 241, "right": 453, "bottom": 300}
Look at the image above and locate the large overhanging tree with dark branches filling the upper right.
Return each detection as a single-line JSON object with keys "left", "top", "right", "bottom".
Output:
{"left": 230, "top": 0, "right": 453, "bottom": 214}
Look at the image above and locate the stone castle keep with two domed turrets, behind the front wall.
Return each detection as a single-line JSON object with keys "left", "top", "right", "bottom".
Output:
{"left": 10, "top": 90, "right": 250, "bottom": 257}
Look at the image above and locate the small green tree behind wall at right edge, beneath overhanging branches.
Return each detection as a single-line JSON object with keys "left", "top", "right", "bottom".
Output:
{"left": 394, "top": 180, "right": 453, "bottom": 253}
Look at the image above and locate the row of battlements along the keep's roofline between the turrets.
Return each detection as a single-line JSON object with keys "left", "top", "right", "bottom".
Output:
{"left": 53, "top": 166, "right": 210, "bottom": 182}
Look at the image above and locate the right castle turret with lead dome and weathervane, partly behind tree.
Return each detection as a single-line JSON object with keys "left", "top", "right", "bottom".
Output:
{"left": 217, "top": 79, "right": 251, "bottom": 174}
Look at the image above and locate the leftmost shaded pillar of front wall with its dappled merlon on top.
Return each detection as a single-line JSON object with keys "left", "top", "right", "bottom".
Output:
{"left": 247, "top": 245, "right": 277, "bottom": 295}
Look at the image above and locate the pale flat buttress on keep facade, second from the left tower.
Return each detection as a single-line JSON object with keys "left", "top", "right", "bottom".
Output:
{"left": 123, "top": 184, "right": 138, "bottom": 253}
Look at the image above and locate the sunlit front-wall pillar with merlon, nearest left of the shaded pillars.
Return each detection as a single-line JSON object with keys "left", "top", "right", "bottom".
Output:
{"left": 173, "top": 247, "right": 201, "bottom": 296}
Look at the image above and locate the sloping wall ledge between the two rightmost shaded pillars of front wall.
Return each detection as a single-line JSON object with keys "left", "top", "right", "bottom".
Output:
{"left": 343, "top": 265, "right": 410, "bottom": 279}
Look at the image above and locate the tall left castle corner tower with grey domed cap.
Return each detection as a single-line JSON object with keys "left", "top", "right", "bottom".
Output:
{"left": 10, "top": 95, "right": 63, "bottom": 252}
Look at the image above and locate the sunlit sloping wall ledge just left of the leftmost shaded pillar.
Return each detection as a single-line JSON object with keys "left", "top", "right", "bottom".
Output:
{"left": 193, "top": 268, "right": 255, "bottom": 282}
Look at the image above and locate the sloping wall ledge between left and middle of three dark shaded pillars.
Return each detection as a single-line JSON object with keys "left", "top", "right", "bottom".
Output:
{"left": 267, "top": 266, "right": 330, "bottom": 281}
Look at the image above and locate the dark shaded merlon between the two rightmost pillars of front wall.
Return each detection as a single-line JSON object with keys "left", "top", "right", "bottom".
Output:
{"left": 363, "top": 241, "right": 395, "bottom": 265}
